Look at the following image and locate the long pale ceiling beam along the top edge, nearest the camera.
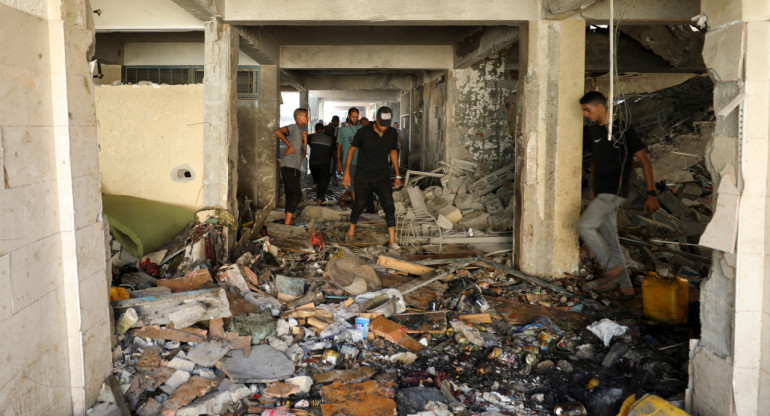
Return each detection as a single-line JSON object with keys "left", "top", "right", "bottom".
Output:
{"left": 219, "top": 0, "right": 542, "bottom": 26}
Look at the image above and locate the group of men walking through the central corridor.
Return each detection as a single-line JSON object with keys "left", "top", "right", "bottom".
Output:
{"left": 275, "top": 106, "right": 401, "bottom": 249}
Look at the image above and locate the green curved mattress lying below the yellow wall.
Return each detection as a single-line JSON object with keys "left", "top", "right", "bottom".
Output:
{"left": 102, "top": 195, "right": 194, "bottom": 258}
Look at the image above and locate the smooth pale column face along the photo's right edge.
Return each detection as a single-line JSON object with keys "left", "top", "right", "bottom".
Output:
{"left": 733, "top": 13, "right": 770, "bottom": 415}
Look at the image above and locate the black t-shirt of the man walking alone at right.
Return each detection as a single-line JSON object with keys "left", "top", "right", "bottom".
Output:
{"left": 583, "top": 123, "right": 646, "bottom": 198}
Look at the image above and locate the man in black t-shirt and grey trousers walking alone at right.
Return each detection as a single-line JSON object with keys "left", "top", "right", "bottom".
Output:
{"left": 577, "top": 91, "right": 660, "bottom": 296}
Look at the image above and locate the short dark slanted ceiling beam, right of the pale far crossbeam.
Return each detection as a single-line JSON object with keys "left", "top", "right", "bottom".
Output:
{"left": 454, "top": 26, "right": 519, "bottom": 68}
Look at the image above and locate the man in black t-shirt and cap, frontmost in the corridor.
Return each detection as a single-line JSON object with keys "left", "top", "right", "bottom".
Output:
{"left": 342, "top": 107, "right": 401, "bottom": 250}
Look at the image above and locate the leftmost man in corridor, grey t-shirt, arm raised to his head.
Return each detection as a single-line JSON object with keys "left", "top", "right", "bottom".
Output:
{"left": 275, "top": 108, "right": 308, "bottom": 225}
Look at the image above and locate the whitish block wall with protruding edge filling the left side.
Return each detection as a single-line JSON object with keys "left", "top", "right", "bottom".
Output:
{"left": 0, "top": 0, "right": 112, "bottom": 415}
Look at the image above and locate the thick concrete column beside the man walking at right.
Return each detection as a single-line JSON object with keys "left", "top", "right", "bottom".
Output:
{"left": 514, "top": 20, "right": 585, "bottom": 277}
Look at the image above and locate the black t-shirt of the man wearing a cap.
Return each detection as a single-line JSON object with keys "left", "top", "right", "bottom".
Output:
{"left": 351, "top": 124, "right": 398, "bottom": 182}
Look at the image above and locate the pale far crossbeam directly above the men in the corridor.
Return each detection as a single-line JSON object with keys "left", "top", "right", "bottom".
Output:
{"left": 280, "top": 45, "right": 454, "bottom": 70}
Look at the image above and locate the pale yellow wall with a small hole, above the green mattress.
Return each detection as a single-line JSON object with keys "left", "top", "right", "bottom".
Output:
{"left": 96, "top": 84, "right": 203, "bottom": 210}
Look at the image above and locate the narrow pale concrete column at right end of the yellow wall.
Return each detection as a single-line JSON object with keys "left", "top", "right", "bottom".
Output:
{"left": 202, "top": 18, "right": 239, "bottom": 216}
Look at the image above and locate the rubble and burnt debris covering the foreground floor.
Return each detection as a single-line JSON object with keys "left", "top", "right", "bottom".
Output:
{"left": 89, "top": 203, "right": 697, "bottom": 416}
